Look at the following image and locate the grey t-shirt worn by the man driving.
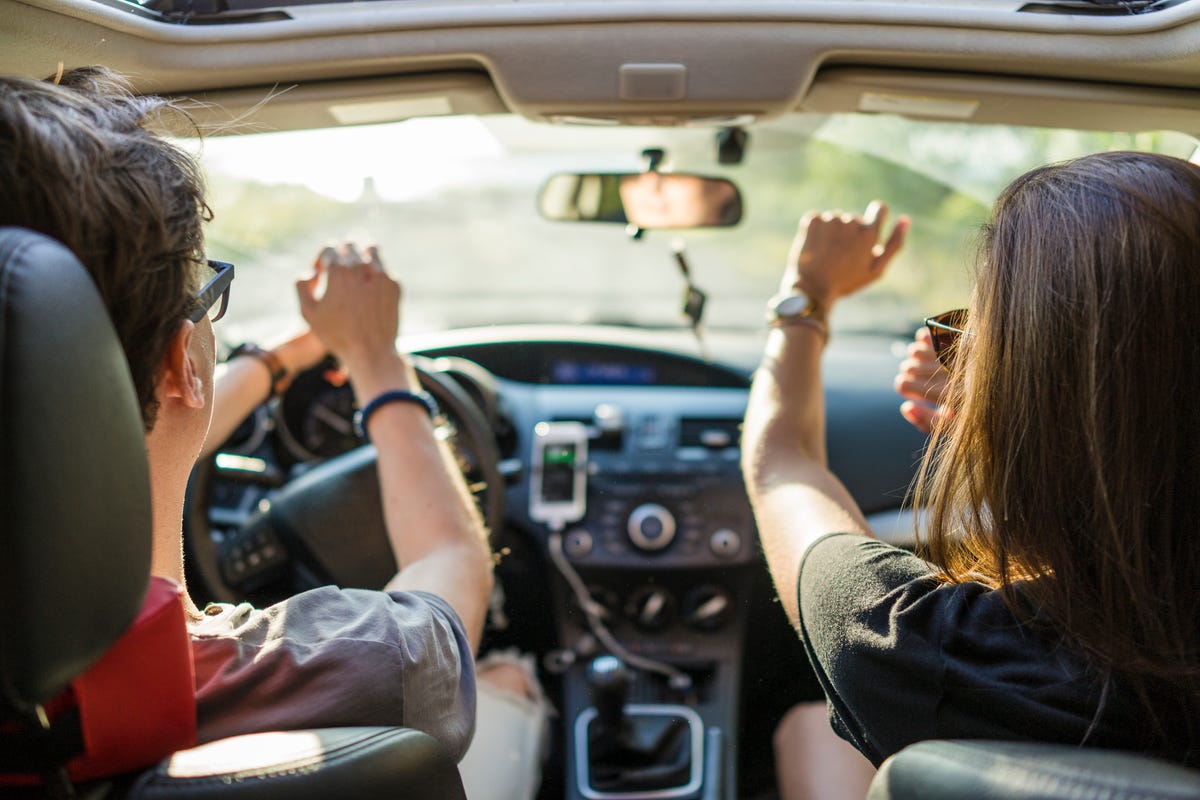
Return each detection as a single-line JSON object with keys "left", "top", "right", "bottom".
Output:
{"left": 190, "top": 587, "right": 475, "bottom": 759}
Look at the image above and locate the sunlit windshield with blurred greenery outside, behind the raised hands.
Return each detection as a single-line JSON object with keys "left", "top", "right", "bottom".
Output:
{"left": 186, "top": 115, "right": 1195, "bottom": 341}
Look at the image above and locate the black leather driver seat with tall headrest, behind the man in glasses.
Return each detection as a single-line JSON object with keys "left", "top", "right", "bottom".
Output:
{"left": 0, "top": 228, "right": 464, "bottom": 800}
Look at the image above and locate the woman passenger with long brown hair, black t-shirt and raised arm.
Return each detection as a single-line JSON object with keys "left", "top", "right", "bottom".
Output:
{"left": 743, "top": 152, "right": 1200, "bottom": 800}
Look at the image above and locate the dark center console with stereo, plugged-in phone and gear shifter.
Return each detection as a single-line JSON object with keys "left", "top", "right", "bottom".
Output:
{"left": 518, "top": 390, "right": 761, "bottom": 800}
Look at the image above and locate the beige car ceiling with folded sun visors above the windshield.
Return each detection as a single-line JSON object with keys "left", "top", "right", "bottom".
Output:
{"left": 0, "top": 0, "right": 1200, "bottom": 133}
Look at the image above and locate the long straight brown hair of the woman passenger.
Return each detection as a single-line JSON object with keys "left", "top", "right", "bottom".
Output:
{"left": 917, "top": 152, "right": 1200, "bottom": 729}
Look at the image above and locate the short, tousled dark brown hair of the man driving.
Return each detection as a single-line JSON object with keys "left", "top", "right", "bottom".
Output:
{"left": 0, "top": 67, "right": 211, "bottom": 431}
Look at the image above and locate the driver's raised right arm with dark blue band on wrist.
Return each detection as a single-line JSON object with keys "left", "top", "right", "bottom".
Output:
{"left": 296, "top": 246, "right": 492, "bottom": 646}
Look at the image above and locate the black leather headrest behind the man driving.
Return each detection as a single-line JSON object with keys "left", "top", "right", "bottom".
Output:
{"left": 0, "top": 228, "right": 150, "bottom": 710}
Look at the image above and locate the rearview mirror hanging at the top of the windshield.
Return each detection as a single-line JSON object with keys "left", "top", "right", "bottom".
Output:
{"left": 538, "top": 172, "right": 742, "bottom": 229}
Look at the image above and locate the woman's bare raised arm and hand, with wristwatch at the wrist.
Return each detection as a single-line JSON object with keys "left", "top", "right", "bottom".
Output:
{"left": 742, "top": 203, "right": 908, "bottom": 625}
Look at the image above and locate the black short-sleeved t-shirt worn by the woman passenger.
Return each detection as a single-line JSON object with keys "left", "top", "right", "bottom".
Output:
{"left": 799, "top": 534, "right": 1200, "bottom": 765}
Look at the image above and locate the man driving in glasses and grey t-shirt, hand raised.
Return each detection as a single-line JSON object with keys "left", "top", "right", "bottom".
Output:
{"left": 0, "top": 67, "right": 540, "bottom": 794}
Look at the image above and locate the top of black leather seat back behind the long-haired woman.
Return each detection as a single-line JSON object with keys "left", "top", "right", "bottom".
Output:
{"left": 866, "top": 741, "right": 1200, "bottom": 800}
